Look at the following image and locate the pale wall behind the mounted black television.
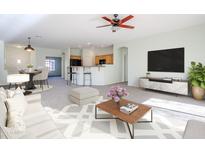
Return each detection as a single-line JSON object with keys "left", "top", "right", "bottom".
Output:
{"left": 115, "top": 25, "right": 205, "bottom": 86}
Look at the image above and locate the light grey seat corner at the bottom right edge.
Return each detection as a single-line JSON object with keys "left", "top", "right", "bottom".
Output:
{"left": 183, "top": 120, "right": 205, "bottom": 139}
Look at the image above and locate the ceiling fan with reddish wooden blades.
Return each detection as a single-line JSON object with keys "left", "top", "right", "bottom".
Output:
{"left": 96, "top": 14, "right": 135, "bottom": 32}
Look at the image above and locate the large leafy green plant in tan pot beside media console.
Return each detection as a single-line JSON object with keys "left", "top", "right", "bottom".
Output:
{"left": 188, "top": 62, "right": 205, "bottom": 100}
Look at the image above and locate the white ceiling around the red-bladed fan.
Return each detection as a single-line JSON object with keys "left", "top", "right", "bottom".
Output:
{"left": 0, "top": 14, "right": 205, "bottom": 49}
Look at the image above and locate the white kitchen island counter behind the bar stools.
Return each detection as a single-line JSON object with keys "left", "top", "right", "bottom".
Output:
{"left": 71, "top": 65, "right": 113, "bottom": 85}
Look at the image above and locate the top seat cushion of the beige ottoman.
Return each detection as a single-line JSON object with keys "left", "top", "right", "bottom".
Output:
{"left": 70, "top": 87, "right": 99, "bottom": 100}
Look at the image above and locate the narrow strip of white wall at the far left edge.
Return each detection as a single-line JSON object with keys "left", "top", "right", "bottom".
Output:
{"left": 0, "top": 40, "right": 7, "bottom": 85}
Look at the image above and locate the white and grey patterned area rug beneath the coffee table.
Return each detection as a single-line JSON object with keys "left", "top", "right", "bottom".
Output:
{"left": 45, "top": 104, "right": 184, "bottom": 139}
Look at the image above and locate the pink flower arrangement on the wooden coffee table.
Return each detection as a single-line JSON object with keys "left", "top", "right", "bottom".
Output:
{"left": 107, "top": 86, "right": 128, "bottom": 102}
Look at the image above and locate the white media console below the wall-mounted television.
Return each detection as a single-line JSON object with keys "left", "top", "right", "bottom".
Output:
{"left": 139, "top": 77, "right": 189, "bottom": 95}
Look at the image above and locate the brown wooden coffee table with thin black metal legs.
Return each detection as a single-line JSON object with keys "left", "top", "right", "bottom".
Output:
{"left": 95, "top": 99, "right": 153, "bottom": 139}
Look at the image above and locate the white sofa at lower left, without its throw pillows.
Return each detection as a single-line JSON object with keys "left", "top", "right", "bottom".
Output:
{"left": 0, "top": 94, "right": 64, "bottom": 139}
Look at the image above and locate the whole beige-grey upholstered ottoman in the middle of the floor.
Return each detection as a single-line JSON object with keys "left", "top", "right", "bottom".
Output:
{"left": 70, "top": 87, "right": 100, "bottom": 104}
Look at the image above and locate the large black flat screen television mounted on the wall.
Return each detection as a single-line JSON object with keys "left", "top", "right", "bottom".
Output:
{"left": 148, "top": 48, "right": 184, "bottom": 73}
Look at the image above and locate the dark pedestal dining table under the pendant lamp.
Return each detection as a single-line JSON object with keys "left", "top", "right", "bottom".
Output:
{"left": 19, "top": 69, "right": 42, "bottom": 90}
